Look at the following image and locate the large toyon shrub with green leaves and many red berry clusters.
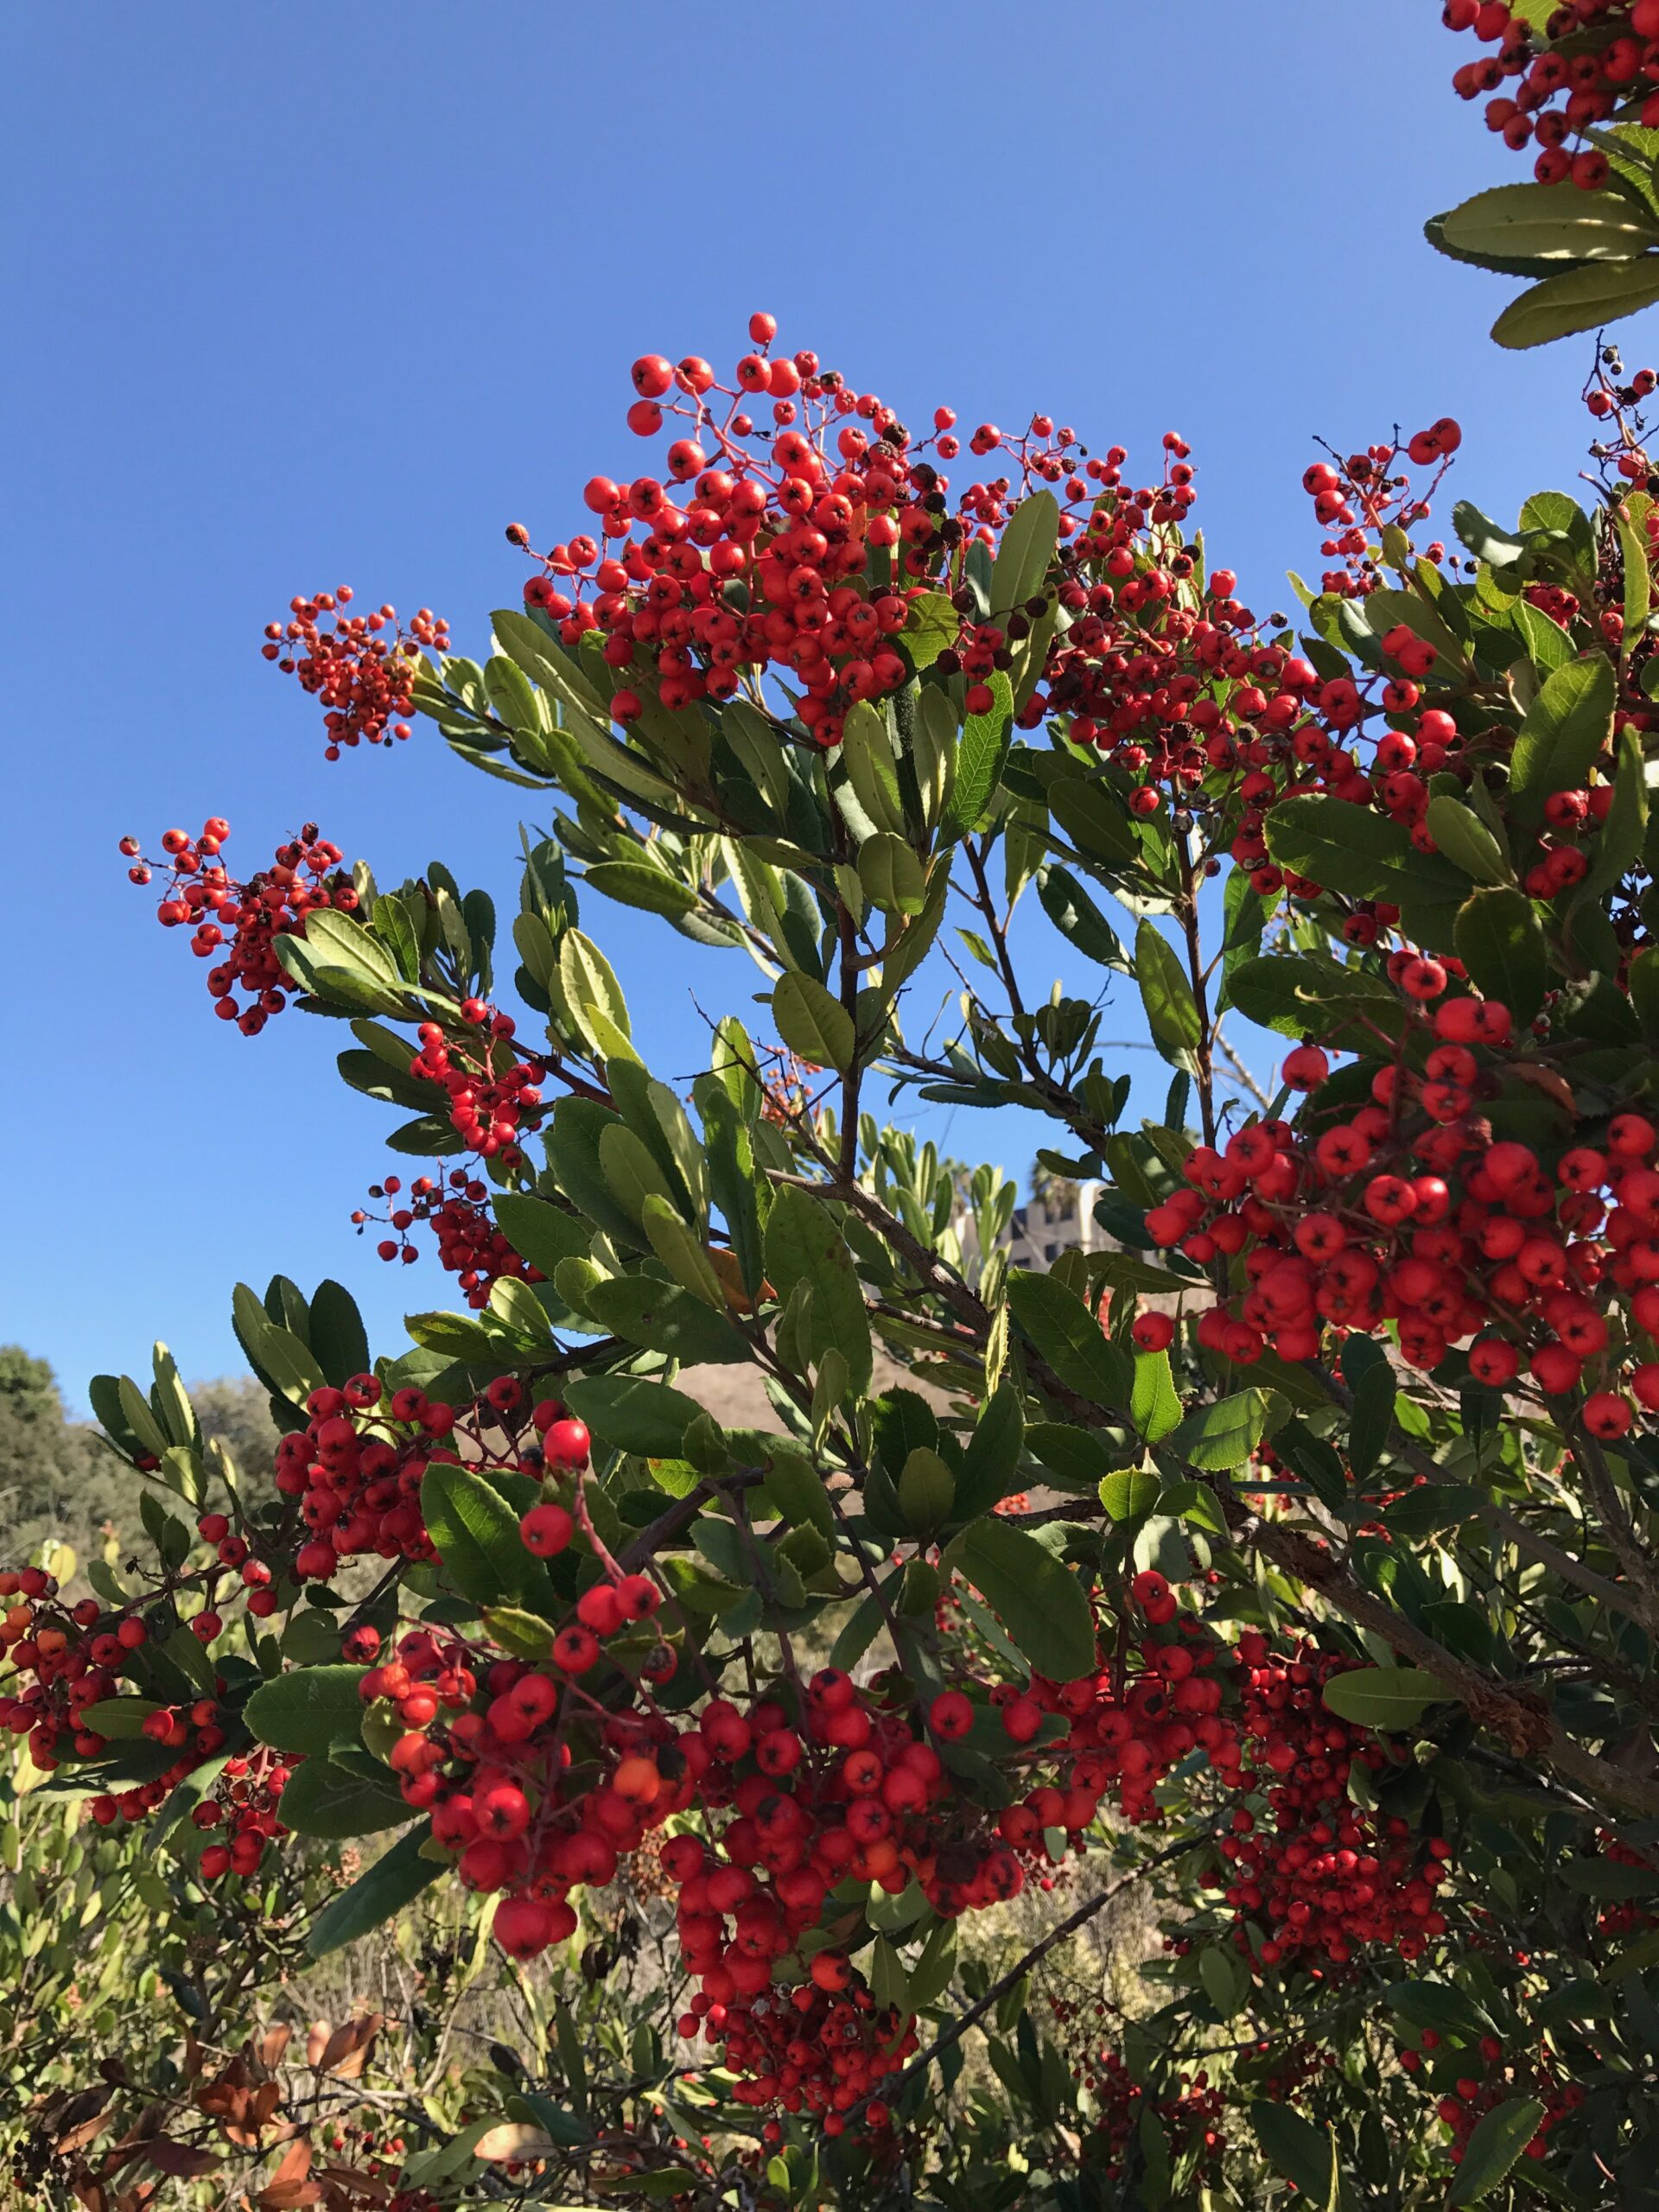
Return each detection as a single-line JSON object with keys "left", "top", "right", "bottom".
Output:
{"left": 22, "top": 267, "right": 1659, "bottom": 2212}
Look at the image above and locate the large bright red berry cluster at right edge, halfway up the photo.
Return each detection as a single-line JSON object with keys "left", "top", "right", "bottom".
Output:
{"left": 1146, "top": 956, "right": 1659, "bottom": 1435}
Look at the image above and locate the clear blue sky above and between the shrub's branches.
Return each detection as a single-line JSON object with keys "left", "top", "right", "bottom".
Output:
{"left": 0, "top": 0, "right": 1635, "bottom": 1400}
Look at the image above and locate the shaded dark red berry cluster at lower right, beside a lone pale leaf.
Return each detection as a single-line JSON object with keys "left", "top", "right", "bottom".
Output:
{"left": 1217, "top": 1630, "right": 1451, "bottom": 1968}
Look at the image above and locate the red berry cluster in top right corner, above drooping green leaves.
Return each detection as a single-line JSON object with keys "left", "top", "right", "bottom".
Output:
{"left": 1442, "top": 0, "right": 1659, "bottom": 193}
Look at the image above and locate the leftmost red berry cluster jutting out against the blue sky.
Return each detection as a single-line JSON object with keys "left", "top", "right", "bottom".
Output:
{"left": 122, "top": 814, "right": 359, "bottom": 1038}
